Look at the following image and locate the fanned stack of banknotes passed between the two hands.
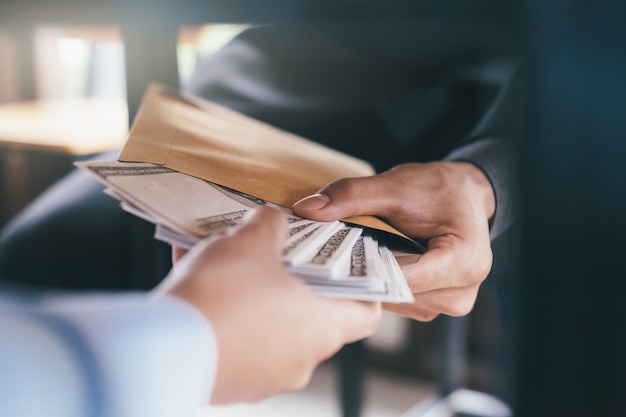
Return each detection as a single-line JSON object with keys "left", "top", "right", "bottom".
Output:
{"left": 76, "top": 161, "right": 413, "bottom": 303}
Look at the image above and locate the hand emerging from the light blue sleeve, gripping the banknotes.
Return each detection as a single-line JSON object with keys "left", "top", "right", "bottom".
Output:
{"left": 157, "top": 207, "right": 381, "bottom": 403}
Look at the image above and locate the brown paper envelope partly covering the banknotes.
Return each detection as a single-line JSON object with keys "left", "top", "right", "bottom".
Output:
{"left": 118, "top": 84, "right": 421, "bottom": 250}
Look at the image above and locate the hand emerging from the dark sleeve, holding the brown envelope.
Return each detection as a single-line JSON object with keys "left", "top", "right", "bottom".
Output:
{"left": 293, "top": 162, "right": 495, "bottom": 321}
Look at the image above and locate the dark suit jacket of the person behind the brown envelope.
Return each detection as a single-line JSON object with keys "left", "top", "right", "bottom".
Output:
{"left": 185, "top": 8, "right": 517, "bottom": 238}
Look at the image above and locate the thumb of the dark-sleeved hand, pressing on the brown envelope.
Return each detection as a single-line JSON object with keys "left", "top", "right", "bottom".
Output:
{"left": 293, "top": 175, "right": 389, "bottom": 221}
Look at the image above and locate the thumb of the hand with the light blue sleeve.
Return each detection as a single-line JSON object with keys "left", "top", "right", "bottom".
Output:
{"left": 232, "top": 206, "right": 287, "bottom": 254}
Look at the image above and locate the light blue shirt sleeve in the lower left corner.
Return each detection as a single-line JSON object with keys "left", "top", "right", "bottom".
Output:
{"left": 0, "top": 294, "right": 217, "bottom": 417}
